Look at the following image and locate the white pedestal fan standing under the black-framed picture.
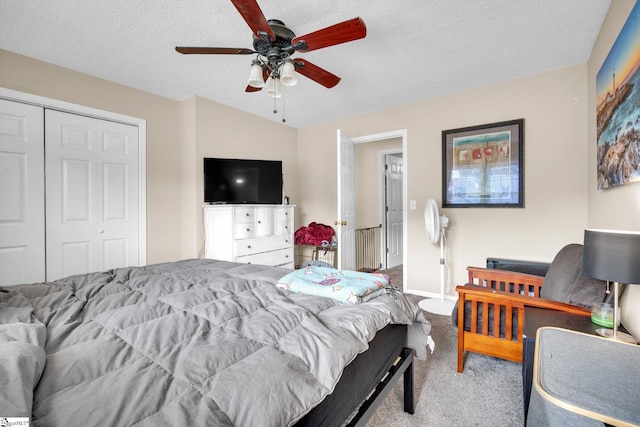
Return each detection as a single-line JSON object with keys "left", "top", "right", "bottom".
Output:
{"left": 418, "top": 199, "right": 455, "bottom": 315}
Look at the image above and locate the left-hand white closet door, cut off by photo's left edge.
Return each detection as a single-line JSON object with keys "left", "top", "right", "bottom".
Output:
{"left": 0, "top": 99, "right": 45, "bottom": 285}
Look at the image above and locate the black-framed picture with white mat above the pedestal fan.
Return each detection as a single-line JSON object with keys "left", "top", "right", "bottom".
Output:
{"left": 442, "top": 119, "right": 524, "bottom": 208}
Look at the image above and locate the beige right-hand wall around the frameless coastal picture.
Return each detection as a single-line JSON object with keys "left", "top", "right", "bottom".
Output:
{"left": 587, "top": 0, "right": 640, "bottom": 338}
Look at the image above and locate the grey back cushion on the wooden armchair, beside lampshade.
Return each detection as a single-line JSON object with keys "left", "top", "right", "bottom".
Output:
{"left": 540, "top": 243, "right": 582, "bottom": 302}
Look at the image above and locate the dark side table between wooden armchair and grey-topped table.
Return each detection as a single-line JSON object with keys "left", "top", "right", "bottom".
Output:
{"left": 522, "top": 307, "right": 601, "bottom": 424}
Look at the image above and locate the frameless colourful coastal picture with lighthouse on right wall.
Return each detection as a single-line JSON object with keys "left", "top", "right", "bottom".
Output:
{"left": 596, "top": 3, "right": 640, "bottom": 189}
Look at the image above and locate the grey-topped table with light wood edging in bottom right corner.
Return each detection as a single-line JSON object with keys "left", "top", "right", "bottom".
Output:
{"left": 528, "top": 328, "right": 640, "bottom": 426}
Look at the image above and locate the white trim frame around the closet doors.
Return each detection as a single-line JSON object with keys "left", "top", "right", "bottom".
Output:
{"left": 0, "top": 87, "right": 147, "bottom": 265}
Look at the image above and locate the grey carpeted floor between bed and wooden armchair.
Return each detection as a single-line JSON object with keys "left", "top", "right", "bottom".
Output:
{"left": 367, "top": 295, "right": 524, "bottom": 427}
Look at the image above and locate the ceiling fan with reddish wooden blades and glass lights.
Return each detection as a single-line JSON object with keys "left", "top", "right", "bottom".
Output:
{"left": 176, "top": 0, "right": 367, "bottom": 98}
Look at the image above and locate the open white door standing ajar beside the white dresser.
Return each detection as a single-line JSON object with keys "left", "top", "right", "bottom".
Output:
{"left": 334, "top": 129, "right": 356, "bottom": 270}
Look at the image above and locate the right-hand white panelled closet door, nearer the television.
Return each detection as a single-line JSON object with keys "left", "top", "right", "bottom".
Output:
{"left": 45, "top": 110, "right": 139, "bottom": 280}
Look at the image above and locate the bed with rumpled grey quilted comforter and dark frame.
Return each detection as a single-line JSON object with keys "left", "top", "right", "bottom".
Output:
{"left": 0, "top": 259, "right": 432, "bottom": 426}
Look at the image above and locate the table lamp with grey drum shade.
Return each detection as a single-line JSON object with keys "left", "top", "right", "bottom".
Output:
{"left": 582, "top": 229, "right": 640, "bottom": 343}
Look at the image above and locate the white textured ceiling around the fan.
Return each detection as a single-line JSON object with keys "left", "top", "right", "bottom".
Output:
{"left": 0, "top": 0, "right": 611, "bottom": 128}
